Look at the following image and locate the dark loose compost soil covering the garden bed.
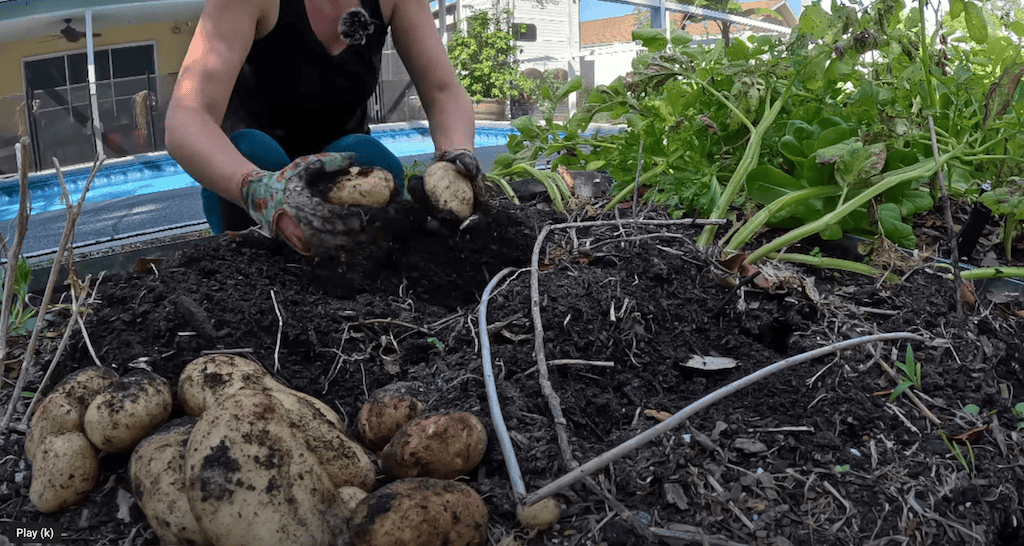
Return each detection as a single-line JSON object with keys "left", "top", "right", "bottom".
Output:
{"left": 0, "top": 195, "right": 1024, "bottom": 546}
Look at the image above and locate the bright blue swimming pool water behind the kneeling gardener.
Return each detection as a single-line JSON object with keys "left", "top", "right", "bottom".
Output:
{"left": 0, "top": 127, "right": 516, "bottom": 220}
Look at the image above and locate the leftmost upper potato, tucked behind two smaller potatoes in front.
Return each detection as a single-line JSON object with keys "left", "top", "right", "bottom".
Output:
{"left": 25, "top": 366, "right": 118, "bottom": 461}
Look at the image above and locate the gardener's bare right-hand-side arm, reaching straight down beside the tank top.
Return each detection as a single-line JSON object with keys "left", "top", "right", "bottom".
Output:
{"left": 391, "top": 0, "right": 474, "bottom": 151}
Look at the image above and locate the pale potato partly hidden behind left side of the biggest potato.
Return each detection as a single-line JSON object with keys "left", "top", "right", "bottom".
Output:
{"left": 128, "top": 417, "right": 210, "bottom": 546}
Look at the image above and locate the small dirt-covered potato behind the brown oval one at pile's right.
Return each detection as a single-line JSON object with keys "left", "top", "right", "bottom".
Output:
{"left": 358, "top": 381, "right": 424, "bottom": 452}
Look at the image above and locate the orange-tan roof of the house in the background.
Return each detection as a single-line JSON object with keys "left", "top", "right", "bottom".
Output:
{"left": 580, "top": 0, "right": 797, "bottom": 45}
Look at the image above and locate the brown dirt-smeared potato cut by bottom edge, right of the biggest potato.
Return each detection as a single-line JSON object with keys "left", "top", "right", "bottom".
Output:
{"left": 348, "top": 477, "right": 487, "bottom": 546}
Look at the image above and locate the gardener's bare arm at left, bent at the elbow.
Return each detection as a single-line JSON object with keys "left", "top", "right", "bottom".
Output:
{"left": 165, "top": 0, "right": 265, "bottom": 205}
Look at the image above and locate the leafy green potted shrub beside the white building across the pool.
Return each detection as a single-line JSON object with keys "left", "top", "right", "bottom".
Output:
{"left": 447, "top": 10, "right": 530, "bottom": 100}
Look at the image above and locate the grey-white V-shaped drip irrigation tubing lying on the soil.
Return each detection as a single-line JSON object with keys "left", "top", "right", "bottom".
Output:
{"left": 479, "top": 267, "right": 926, "bottom": 506}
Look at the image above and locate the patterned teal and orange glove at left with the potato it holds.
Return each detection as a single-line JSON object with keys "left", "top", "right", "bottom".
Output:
{"left": 242, "top": 154, "right": 395, "bottom": 256}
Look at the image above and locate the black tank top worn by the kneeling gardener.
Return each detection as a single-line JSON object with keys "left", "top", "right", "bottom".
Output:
{"left": 223, "top": 0, "right": 388, "bottom": 159}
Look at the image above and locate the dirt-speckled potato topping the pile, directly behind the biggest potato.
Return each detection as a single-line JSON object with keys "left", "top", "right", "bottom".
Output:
{"left": 178, "top": 354, "right": 345, "bottom": 430}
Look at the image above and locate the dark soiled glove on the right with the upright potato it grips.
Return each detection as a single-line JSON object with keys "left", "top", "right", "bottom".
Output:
{"left": 410, "top": 150, "right": 484, "bottom": 220}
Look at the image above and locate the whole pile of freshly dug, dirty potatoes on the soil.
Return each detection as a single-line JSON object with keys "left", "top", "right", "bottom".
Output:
{"left": 26, "top": 354, "right": 487, "bottom": 546}
